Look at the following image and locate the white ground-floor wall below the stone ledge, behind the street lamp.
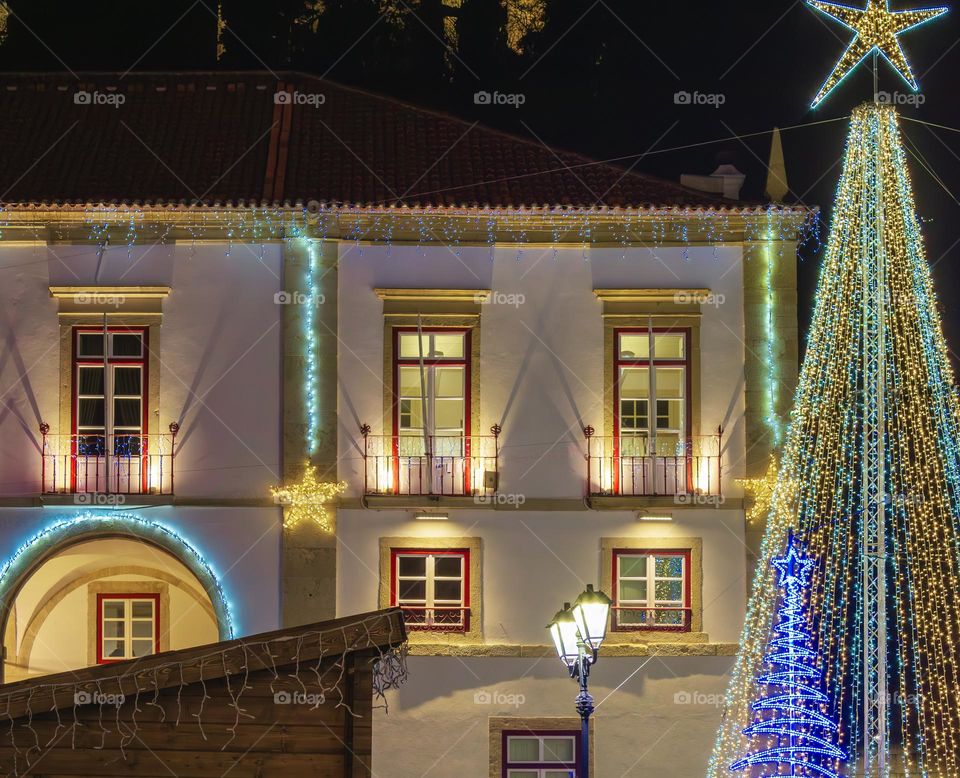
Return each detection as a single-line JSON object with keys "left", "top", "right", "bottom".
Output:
{"left": 373, "top": 657, "right": 733, "bottom": 778}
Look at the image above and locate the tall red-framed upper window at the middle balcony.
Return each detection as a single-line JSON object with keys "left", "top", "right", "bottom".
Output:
{"left": 393, "top": 327, "right": 470, "bottom": 457}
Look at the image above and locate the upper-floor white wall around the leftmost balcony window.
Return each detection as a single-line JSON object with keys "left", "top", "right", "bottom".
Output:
{"left": 0, "top": 243, "right": 283, "bottom": 497}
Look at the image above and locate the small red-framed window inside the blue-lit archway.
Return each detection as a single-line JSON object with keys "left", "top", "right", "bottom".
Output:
{"left": 97, "top": 594, "right": 160, "bottom": 664}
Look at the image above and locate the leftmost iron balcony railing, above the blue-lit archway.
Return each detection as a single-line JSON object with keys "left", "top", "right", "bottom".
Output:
{"left": 40, "top": 422, "right": 179, "bottom": 495}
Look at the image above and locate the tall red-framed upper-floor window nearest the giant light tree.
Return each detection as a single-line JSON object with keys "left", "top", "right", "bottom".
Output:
{"left": 614, "top": 329, "right": 691, "bottom": 457}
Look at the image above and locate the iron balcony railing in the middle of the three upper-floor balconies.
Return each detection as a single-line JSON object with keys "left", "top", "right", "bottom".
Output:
{"left": 361, "top": 425, "right": 500, "bottom": 497}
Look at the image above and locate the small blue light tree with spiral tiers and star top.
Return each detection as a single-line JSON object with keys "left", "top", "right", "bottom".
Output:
{"left": 730, "top": 532, "right": 848, "bottom": 778}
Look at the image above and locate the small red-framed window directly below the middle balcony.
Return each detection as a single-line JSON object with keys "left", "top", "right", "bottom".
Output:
{"left": 391, "top": 549, "right": 470, "bottom": 632}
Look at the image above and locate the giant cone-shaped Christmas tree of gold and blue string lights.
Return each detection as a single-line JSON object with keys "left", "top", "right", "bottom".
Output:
{"left": 708, "top": 42, "right": 960, "bottom": 778}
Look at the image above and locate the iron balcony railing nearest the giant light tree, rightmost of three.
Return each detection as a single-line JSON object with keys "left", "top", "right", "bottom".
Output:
{"left": 584, "top": 427, "right": 722, "bottom": 494}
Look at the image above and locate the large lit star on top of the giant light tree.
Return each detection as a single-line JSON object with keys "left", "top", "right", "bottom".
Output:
{"left": 807, "top": 0, "right": 950, "bottom": 108}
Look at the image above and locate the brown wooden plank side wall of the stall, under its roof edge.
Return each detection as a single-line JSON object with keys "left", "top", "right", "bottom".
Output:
{"left": 0, "top": 649, "right": 380, "bottom": 778}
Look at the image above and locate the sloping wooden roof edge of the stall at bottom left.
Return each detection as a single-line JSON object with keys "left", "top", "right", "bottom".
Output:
{"left": 0, "top": 608, "right": 406, "bottom": 721}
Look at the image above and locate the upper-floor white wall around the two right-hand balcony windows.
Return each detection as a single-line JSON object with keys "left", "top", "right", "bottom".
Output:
{"left": 339, "top": 244, "right": 744, "bottom": 498}
